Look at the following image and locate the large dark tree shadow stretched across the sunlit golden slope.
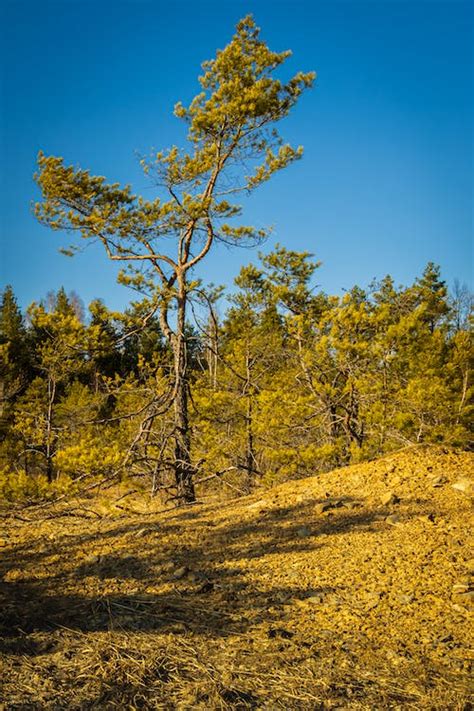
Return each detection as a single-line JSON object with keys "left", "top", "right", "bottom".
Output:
{"left": 0, "top": 501, "right": 419, "bottom": 655}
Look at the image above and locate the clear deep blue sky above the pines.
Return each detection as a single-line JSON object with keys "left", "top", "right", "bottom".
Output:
{"left": 0, "top": 0, "right": 473, "bottom": 308}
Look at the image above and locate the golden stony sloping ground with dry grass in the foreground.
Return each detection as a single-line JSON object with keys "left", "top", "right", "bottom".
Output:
{"left": 0, "top": 448, "right": 474, "bottom": 711}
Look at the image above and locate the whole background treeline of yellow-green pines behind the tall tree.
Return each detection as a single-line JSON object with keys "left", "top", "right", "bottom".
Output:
{"left": 0, "top": 246, "right": 473, "bottom": 500}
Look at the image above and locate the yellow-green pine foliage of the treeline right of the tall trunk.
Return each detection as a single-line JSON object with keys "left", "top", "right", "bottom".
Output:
{"left": 192, "top": 253, "right": 472, "bottom": 483}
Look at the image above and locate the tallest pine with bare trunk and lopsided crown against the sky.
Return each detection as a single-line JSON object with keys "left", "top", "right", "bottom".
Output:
{"left": 36, "top": 16, "right": 314, "bottom": 501}
